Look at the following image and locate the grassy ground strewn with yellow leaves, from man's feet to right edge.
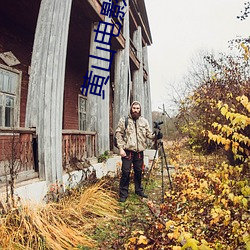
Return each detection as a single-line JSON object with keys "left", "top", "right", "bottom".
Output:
{"left": 82, "top": 144, "right": 250, "bottom": 250}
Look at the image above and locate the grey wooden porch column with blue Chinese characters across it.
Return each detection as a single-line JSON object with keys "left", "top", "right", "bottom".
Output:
{"left": 87, "top": 19, "right": 110, "bottom": 155}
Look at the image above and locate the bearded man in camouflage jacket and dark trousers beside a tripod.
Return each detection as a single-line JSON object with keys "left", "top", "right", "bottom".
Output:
{"left": 115, "top": 101, "right": 158, "bottom": 202}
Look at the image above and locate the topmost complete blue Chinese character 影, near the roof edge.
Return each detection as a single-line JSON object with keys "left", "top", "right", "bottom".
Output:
{"left": 101, "top": 0, "right": 127, "bottom": 21}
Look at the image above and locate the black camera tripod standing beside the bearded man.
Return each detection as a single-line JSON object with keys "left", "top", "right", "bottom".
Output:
{"left": 144, "top": 128, "right": 172, "bottom": 203}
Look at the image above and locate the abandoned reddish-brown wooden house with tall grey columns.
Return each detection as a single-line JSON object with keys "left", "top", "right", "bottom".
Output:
{"left": 0, "top": 0, "right": 152, "bottom": 193}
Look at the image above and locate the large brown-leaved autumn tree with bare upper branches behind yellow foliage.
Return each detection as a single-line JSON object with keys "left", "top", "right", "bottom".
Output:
{"left": 177, "top": 43, "right": 250, "bottom": 152}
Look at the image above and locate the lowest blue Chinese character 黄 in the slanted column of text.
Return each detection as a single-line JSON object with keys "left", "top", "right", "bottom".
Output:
{"left": 81, "top": 70, "right": 109, "bottom": 99}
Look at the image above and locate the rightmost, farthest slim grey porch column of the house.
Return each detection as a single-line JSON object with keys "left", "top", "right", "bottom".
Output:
{"left": 142, "top": 45, "right": 152, "bottom": 125}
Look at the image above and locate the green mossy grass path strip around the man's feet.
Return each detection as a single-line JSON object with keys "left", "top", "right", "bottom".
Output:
{"left": 81, "top": 165, "right": 171, "bottom": 250}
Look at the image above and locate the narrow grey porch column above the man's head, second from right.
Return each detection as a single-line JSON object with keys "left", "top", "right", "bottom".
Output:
{"left": 133, "top": 26, "right": 147, "bottom": 116}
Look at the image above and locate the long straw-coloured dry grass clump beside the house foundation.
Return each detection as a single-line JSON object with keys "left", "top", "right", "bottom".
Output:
{"left": 0, "top": 182, "right": 119, "bottom": 250}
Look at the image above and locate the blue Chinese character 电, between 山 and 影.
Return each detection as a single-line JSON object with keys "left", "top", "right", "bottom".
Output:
{"left": 94, "top": 21, "right": 121, "bottom": 45}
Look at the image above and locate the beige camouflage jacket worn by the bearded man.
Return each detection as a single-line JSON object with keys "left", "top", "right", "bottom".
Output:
{"left": 115, "top": 115, "right": 155, "bottom": 152}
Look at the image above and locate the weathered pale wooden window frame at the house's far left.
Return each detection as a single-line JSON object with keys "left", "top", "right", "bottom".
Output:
{"left": 0, "top": 63, "right": 22, "bottom": 128}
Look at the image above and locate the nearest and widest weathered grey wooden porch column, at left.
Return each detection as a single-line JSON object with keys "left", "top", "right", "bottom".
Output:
{"left": 25, "top": 0, "right": 72, "bottom": 183}
